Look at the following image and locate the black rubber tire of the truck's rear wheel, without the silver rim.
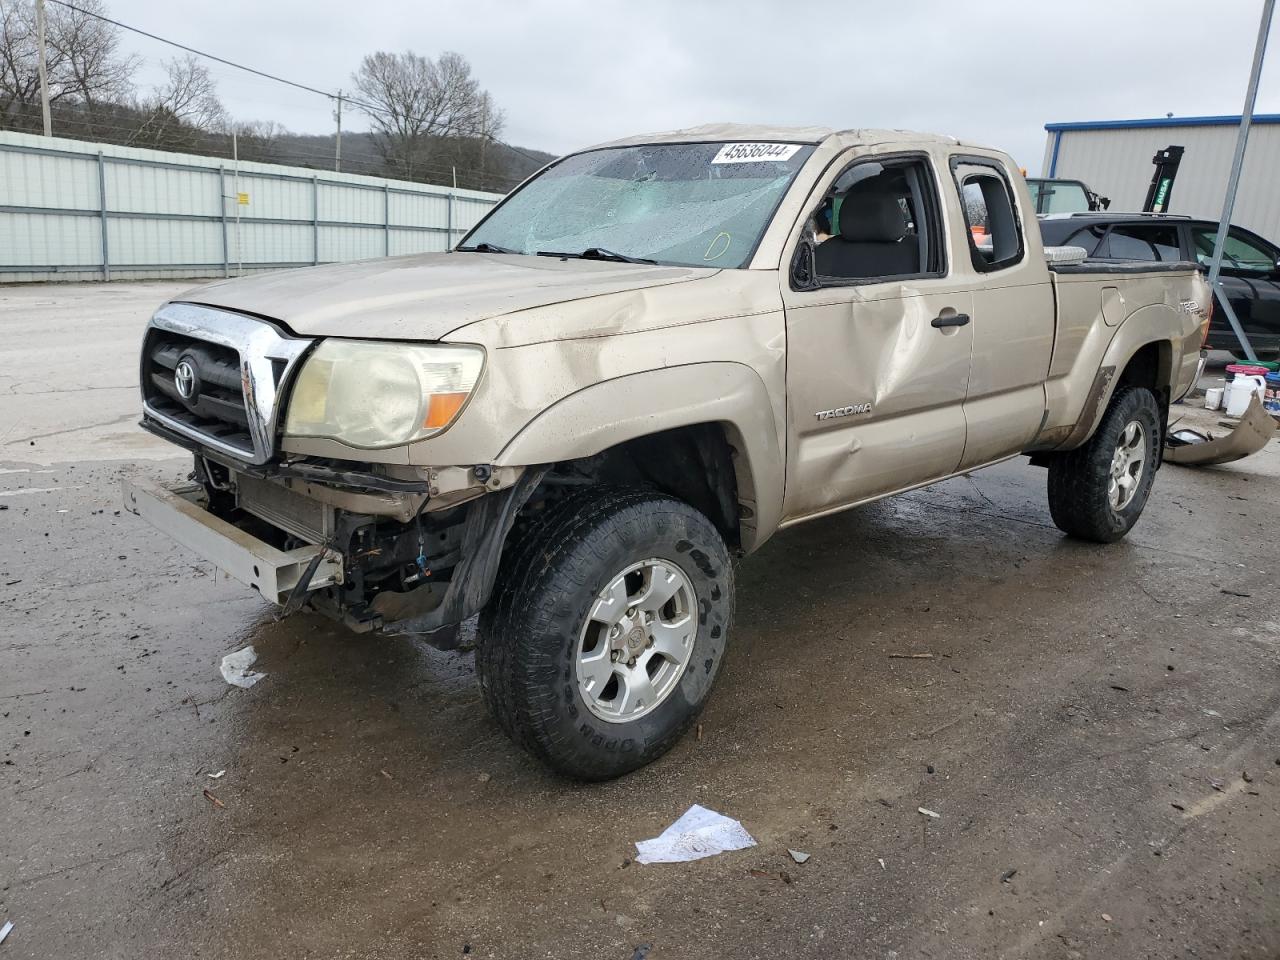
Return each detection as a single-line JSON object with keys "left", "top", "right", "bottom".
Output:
{"left": 1048, "top": 387, "right": 1164, "bottom": 543}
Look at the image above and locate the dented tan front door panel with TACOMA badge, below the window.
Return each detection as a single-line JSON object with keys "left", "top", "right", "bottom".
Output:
{"left": 783, "top": 279, "right": 973, "bottom": 520}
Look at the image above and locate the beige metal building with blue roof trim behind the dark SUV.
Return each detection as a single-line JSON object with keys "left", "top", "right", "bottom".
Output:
{"left": 1041, "top": 114, "right": 1280, "bottom": 243}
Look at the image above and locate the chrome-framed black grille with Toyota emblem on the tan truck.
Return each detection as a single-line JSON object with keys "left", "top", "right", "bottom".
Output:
{"left": 141, "top": 303, "right": 311, "bottom": 463}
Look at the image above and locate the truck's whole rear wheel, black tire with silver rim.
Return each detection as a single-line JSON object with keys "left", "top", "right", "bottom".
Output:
{"left": 1048, "top": 387, "right": 1161, "bottom": 543}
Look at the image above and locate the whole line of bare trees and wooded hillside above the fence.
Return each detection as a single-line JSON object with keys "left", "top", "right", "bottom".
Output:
{"left": 0, "top": 0, "right": 550, "bottom": 192}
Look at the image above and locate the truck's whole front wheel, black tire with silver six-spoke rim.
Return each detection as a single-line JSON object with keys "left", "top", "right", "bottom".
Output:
{"left": 476, "top": 490, "right": 733, "bottom": 780}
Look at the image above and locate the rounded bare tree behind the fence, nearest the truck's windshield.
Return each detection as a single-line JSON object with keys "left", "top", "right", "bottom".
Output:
{"left": 352, "top": 51, "right": 503, "bottom": 178}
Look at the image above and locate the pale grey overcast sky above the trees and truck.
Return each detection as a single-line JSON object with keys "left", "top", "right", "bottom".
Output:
{"left": 109, "top": 0, "right": 1280, "bottom": 175}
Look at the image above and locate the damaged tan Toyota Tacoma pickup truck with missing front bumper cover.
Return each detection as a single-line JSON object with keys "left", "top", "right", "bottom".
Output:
{"left": 125, "top": 125, "right": 1210, "bottom": 778}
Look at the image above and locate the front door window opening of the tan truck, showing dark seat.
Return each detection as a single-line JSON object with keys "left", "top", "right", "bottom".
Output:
{"left": 805, "top": 159, "right": 946, "bottom": 287}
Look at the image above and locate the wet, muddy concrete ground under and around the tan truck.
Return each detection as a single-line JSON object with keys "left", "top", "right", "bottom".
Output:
{"left": 0, "top": 284, "right": 1280, "bottom": 960}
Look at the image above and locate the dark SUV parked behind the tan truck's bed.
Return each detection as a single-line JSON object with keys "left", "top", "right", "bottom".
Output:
{"left": 1041, "top": 212, "right": 1280, "bottom": 360}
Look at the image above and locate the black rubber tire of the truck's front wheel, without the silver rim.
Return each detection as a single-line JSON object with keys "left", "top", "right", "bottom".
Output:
{"left": 476, "top": 488, "right": 733, "bottom": 781}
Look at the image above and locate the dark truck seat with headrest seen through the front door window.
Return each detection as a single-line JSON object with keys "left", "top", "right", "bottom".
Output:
{"left": 817, "top": 191, "right": 920, "bottom": 279}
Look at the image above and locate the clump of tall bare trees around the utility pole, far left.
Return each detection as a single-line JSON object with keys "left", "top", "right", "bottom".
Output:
{"left": 0, "top": 0, "right": 141, "bottom": 128}
